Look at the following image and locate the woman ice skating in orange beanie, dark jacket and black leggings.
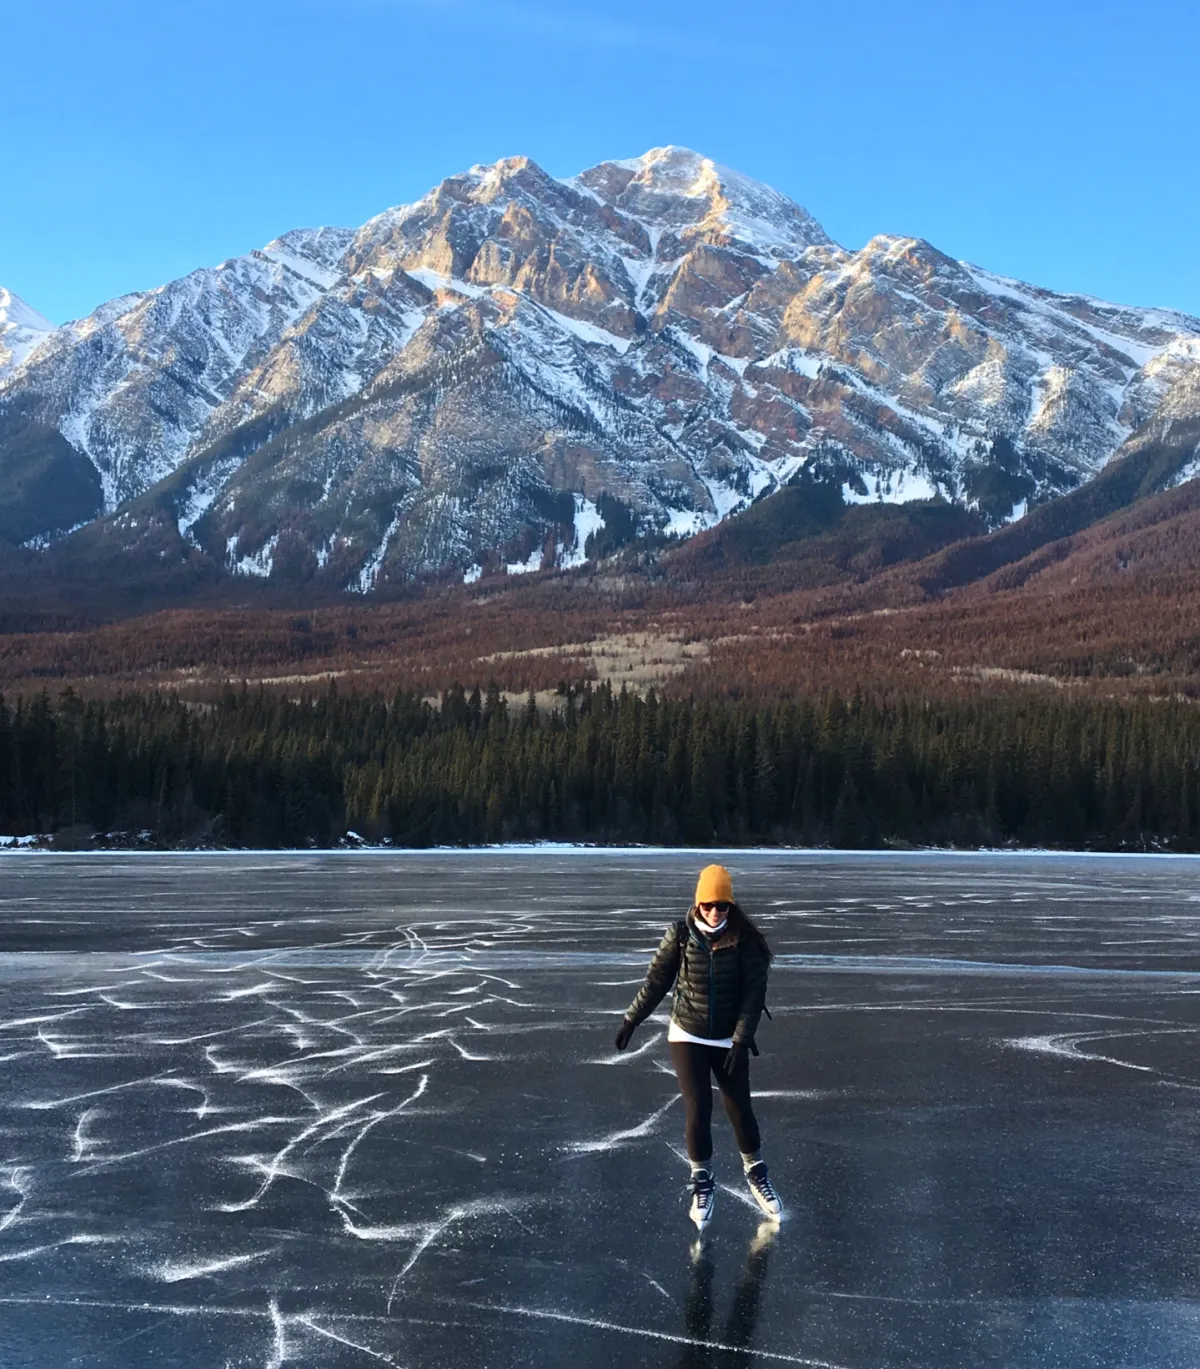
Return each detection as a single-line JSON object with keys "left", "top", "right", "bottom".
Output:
{"left": 617, "top": 865, "right": 783, "bottom": 1231}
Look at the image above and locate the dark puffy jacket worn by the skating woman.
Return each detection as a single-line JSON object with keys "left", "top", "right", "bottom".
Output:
{"left": 625, "top": 913, "right": 768, "bottom": 1054}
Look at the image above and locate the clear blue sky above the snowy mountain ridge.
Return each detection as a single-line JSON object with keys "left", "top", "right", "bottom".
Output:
{"left": 7, "top": 0, "right": 1200, "bottom": 322}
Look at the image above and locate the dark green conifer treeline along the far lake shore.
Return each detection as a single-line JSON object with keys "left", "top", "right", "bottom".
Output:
{"left": 0, "top": 687, "right": 1200, "bottom": 850}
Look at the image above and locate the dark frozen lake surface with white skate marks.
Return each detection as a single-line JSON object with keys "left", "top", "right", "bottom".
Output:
{"left": 0, "top": 850, "right": 1200, "bottom": 1369}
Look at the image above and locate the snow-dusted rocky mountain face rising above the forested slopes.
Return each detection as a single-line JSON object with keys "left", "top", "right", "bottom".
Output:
{"left": 0, "top": 148, "right": 1200, "bottom": 591}
